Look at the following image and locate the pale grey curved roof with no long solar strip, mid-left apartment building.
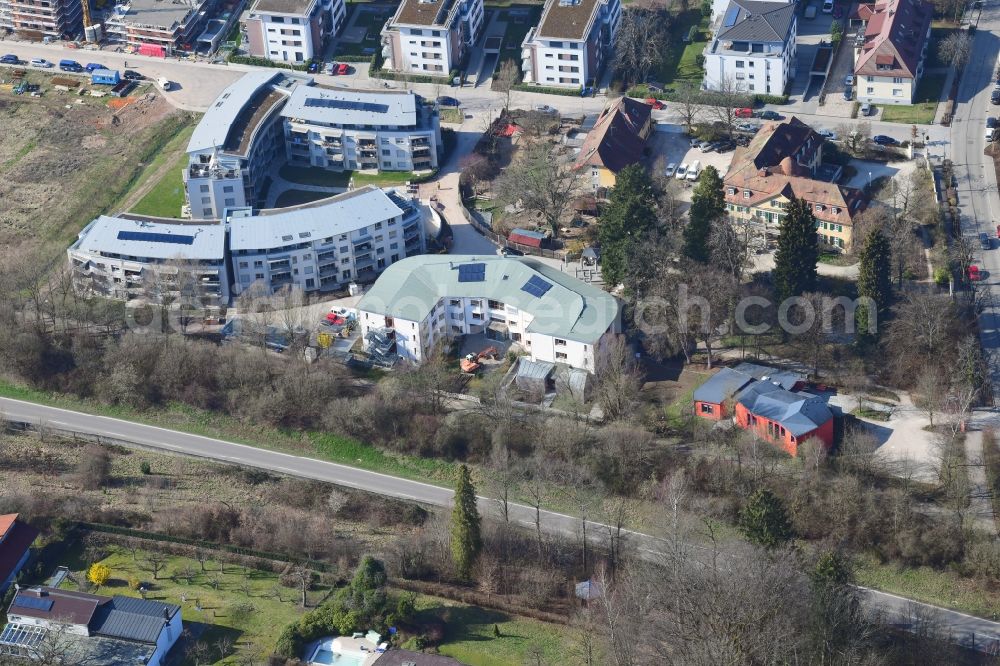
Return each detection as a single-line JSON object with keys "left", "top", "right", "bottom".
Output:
{"left": 229, "top": 185, "right": 403, "bottom": 251}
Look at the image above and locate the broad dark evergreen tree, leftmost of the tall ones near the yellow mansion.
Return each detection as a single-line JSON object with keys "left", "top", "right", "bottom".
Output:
{"left": 597, "top": 164, "right": 657, "bottom": 285}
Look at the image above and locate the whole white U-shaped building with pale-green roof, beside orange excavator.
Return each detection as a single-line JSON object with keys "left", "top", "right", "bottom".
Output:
{"left": 357, "top": 255, "right": 621, "bottom": 373}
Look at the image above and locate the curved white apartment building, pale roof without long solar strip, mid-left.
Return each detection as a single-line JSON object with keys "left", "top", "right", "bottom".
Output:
{"left": 226, "top": 185, "right": 429, "bottom": 296}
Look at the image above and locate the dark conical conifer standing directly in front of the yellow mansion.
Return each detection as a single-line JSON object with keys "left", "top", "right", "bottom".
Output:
{"left": 774, "top": 197, "right": 819, "bottom": 300}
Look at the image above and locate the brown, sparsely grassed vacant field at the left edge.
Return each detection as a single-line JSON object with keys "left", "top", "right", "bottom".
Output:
{"left": 0, "top": 71, "right": 191, "bottom": 262}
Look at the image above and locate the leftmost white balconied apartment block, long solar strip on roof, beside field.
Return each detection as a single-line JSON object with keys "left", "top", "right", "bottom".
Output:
{"left": 67, "top": 215, "right": 229, "bottom": 308}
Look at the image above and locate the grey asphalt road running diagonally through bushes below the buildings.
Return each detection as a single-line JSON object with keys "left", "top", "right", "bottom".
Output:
{"left": 0, "top": 398, "right": 1000, "bottom": 651}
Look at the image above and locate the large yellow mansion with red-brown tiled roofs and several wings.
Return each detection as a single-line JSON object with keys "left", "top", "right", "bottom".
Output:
{"left": 723, "top": 117, "right": 866, "bottom": 250}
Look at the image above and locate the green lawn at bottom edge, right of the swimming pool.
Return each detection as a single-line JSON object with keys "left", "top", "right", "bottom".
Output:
{"left": 416, "top": 596, "right": 578, "bottom": 666}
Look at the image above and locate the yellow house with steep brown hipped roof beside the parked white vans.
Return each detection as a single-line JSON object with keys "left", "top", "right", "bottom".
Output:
{"left": 576, "top": 97, "right": 653, "bottom": 191}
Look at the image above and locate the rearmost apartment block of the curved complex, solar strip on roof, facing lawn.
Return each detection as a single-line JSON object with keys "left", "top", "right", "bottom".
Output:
{"left": 281, "top": 86, "right": 443, "bottom": 171}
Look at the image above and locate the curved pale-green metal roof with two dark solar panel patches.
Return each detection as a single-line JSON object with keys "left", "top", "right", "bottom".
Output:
{"left": 358, "top": 254, "right": 619, "bottom": 344}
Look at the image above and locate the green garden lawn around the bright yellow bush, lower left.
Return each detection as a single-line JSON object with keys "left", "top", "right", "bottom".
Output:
{"left": 62, "top": 546, "right": 316, "bottom": 664}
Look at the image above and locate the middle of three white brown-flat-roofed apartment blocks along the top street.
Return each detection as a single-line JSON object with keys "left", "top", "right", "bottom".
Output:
{"left": 382, "top": 0, "right": 483, "bottom": 76}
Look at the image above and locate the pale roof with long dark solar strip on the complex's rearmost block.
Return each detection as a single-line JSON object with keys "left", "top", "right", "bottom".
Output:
{"left": 281, "top": 86, "right": 418, "bottom": 127}
